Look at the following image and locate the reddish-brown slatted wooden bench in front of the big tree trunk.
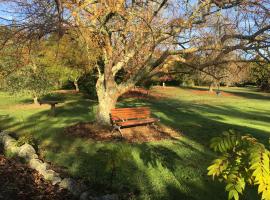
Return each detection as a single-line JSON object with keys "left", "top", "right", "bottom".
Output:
{"left": 111, "top": 107, "right": 159, "bottom": 134}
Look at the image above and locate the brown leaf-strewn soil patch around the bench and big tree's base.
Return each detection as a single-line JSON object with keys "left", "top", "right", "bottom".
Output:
{"left": 65, "top": 122, "right": 181, "bottom": 143}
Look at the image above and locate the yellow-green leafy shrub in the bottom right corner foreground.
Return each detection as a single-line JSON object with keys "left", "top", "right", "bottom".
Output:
{"left": 208, "top": 130, "right": 270, "bottom": 200}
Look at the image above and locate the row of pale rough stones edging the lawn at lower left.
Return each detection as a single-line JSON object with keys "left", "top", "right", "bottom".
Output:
{"left": 0, "top": 131, "right": 119, "bottom": 200}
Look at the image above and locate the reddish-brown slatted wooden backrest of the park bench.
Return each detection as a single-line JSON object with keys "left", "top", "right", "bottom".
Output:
{"left": 111, "top": 107, "right": 151, "bottom": 121}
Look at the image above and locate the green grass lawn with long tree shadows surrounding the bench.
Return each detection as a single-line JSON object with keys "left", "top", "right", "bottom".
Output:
{"left": 0, "top": 88, "right": 270, "bottom": 200}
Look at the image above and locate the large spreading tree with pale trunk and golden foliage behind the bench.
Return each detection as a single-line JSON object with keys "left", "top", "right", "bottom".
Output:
{"left": 2, "top": 0, "right": 270, "bottom": 125}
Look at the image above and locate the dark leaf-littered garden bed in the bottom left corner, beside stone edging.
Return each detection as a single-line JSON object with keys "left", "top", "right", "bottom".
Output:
{"left": 0, "top": 145, "right": 76, "bottom": 200}
